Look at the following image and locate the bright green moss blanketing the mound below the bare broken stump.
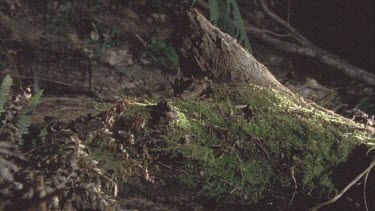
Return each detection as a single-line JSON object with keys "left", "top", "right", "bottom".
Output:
{"left": 92, "top": 85, "right": 374, "bottom": 203}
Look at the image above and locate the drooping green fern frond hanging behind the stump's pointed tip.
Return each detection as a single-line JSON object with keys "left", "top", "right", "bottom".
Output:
{"left": 200, "top": 0, "right": 252, "bottom": 54}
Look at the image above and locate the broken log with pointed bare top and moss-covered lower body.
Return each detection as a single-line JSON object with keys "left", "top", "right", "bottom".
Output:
{"left": 165, "top": 10, "right": 375, "bottom": 209}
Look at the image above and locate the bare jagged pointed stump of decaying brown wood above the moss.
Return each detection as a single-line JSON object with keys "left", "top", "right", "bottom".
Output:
{"left": 176, "top": 10, "right": 290, "bottom": 96}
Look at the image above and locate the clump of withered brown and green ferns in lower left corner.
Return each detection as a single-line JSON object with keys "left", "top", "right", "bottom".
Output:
{"left": 0, "top": 76, "right": 117, "bottom": 210}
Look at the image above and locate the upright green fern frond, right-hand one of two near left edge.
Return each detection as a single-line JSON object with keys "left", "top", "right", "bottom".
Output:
{"left": 16, "top": 90, "right": 43, "bottom": 135}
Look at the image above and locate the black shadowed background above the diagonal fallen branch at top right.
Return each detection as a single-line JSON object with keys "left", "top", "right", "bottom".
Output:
{"left": 275, "top": 0, "right": 375, "bottom": 73}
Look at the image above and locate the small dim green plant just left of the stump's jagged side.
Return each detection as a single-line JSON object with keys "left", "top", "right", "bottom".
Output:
{"left": 147, "top": 37, "right": 178, "bottom": 70}
